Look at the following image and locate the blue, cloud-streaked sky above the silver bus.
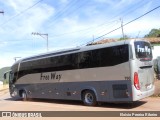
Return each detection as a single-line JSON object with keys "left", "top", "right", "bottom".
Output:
{"left": 0, "top": 0, "right": 160, "bottom": 68}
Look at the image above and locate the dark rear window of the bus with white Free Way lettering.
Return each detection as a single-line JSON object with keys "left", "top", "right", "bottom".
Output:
{"left": 134, "top": 41, "right": 152, "bottom": 61}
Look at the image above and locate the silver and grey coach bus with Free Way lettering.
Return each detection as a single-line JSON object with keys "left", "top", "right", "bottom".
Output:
{"left": 4, "top": 39, "right": 155, "bottom": 106}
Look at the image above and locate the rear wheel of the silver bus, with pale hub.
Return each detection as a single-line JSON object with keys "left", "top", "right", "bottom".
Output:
{"left": 82, "top": 90, "right": 97, "bottom": 106}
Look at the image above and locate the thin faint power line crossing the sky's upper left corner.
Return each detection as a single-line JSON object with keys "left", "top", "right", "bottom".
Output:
{"left": 0, "top": 0, "right": 43, "bottom": 26}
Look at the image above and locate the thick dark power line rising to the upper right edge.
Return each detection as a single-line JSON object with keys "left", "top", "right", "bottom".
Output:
{"left": 83, "top": 5, "right": 160, "bottom": 43}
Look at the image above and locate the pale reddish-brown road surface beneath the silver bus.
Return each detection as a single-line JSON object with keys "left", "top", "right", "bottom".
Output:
{"left": 0, "top": 91, "right": 160, "bottom": 120}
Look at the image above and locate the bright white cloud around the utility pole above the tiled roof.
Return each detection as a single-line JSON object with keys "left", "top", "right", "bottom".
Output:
{"left": 104, "top": 16, "right": 160, "bottom": 38}
